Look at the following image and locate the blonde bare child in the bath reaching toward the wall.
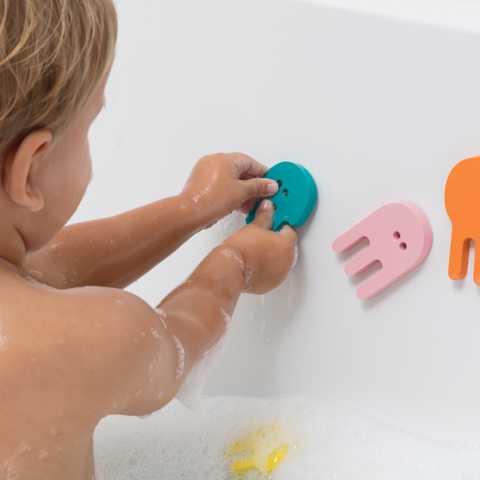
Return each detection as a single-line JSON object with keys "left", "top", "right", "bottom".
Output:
{"left": 0, "top": 0, "right": 296, "bottom": 480}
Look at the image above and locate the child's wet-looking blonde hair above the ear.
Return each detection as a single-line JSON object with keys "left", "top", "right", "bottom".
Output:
{"left": 0, "top": 0, "right": 117, "bottom": 148}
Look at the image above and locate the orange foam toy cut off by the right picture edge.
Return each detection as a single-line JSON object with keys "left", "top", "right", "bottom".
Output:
{"left": 445, "top": 157, "right": 480, "bottom": 285}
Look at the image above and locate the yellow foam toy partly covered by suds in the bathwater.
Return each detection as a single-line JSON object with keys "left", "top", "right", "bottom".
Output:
{"left": 227, "top": 425, "right": 288, "bottom": 475}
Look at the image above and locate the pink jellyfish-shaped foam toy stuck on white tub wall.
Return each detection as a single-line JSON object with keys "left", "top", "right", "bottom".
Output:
{"left": 332, "top": 202, "right": 433, "bottom": 300}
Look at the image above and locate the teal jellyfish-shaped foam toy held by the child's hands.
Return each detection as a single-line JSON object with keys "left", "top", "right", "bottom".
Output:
{"left": 247, "top": 162, "right": 317, "bottom": 232}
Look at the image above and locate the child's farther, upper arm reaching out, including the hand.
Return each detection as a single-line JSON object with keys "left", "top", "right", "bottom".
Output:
{"left": 26, "top": 153, "right": 276, "bottom": 289}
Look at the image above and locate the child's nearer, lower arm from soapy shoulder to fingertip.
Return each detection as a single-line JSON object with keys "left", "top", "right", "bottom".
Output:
{"left": 52, "top": 202, "right": 296, "bottom": 417}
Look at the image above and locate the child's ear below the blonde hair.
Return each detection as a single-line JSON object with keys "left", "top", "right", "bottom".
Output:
{"left": 3, "top": 130, "right": 53, "bottom": 212}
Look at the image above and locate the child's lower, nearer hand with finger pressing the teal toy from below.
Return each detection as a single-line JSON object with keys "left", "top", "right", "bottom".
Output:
{"left": 222, "top": 200, "right": 297, "bottom": 295}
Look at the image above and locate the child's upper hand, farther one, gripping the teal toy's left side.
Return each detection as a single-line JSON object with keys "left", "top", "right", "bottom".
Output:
{"left": 181, "top": 153, "right": 278, "bottom": 224}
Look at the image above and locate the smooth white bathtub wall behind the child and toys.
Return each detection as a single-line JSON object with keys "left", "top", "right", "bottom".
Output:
{"left": 73, "top": 0, "right": 480, "bottom": 441}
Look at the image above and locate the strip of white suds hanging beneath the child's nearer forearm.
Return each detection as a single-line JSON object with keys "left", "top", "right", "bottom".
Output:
{"left": 176, "top": 308, "right": 232, "bottom": 411}
